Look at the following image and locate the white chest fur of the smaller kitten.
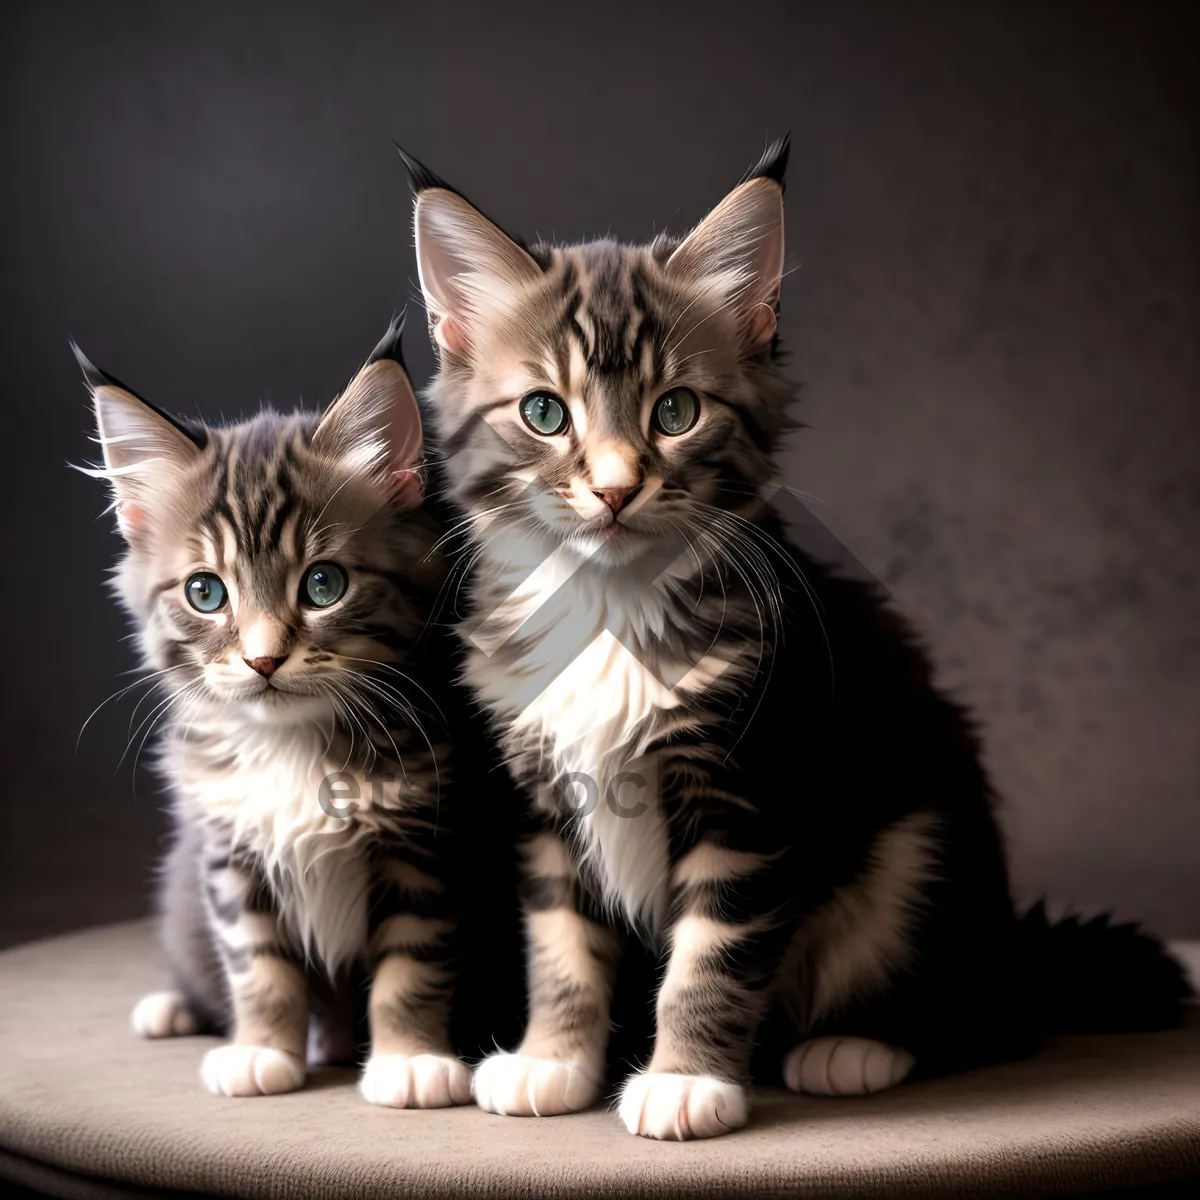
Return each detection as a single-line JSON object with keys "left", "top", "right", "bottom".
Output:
{"left": 180, "top": 722, "right": 373, "bottom": 972}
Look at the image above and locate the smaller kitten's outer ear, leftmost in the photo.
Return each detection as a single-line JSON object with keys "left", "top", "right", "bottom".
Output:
{"left": 71, "top": 341, "right": 208, "bottom": 541}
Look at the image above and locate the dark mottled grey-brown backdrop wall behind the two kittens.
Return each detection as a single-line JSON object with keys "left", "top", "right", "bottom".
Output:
{"left": 0, "top": 0, "right": 1200, "bottom": 942}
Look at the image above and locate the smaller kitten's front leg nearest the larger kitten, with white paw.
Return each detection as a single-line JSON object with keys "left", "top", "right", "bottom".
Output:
{"left": 359, "top": 856, "right": 470, "bottom": 1109}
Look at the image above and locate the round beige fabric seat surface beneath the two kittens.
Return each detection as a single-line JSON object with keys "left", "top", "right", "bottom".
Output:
{"left": 0, "top": 923, "right": 1200, "bottom": 1198}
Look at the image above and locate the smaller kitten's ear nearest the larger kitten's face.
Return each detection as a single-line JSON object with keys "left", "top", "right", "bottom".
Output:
{"left": 312, "top": 312, "right": 424, "bottom": 509}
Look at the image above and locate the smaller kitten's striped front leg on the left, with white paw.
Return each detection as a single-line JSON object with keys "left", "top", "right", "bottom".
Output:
{"left": 200, "top": 850, "right": 308, "bottom": 1096}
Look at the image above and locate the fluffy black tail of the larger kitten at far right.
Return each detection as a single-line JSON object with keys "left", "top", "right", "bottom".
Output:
{"left": 1018, "top": 901, "right": 1193, "bottom": 1033}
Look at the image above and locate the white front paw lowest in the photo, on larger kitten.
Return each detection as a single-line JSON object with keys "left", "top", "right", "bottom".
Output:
{"left": 617, "top": 1073, "right": 750, "bottom": 1141}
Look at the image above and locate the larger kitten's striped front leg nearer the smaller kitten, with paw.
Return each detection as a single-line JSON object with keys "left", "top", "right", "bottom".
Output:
{"left": 474, "top": 833, "right": 622, "bottom": 1116}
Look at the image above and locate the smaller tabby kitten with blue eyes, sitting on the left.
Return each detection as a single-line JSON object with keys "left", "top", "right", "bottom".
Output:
{"left": 76, "top": 317, "right": 470, "bottom": 1108}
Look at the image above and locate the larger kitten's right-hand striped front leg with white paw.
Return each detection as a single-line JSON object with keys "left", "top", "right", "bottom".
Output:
{"left": 619, "top": 811, "right": 794, "bottom": 1140}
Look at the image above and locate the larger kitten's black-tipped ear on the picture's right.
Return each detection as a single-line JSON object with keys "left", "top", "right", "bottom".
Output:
{"left": 666, "top": 137, "right": 788, "bottom": 354}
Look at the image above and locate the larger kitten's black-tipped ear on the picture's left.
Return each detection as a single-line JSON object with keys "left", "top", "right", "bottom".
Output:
{"left": 396, "top": 146, "right": 541, "bottom": 358}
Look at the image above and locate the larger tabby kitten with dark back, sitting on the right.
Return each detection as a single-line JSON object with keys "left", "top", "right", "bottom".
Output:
{"left": 406, "top": 140, "right": 1183, "bottom": 1139}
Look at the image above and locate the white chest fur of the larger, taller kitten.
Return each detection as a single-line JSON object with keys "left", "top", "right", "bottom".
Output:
{"left": 468, "top": 553, "right": 725, "bottom": 929}
